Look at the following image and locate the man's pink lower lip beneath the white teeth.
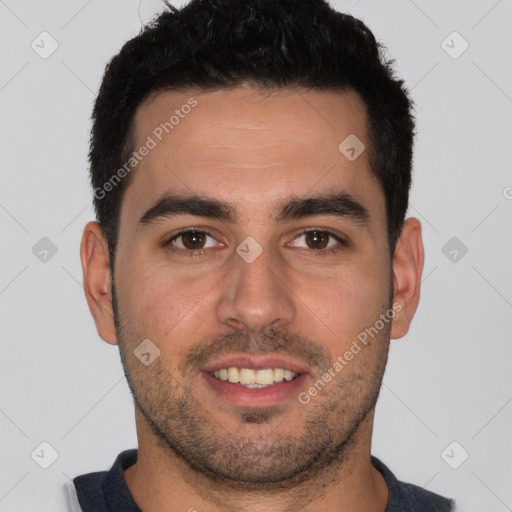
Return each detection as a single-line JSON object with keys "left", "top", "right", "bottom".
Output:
{"left": 201, "top": 372, "right": 307, "bottom": 407}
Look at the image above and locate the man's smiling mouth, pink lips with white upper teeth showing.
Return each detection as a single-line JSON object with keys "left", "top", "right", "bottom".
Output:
{"left": 201, "top": 354, "right": 309, "bottom": 407}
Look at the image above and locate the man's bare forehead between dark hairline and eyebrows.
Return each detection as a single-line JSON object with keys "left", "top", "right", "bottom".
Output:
{"left": 123, "top": 87, "right": 384, "bottom": 225}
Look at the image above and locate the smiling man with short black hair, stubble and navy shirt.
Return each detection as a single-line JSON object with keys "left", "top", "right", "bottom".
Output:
{"left": 73, "top": 0, "right": 452, "bottom": 512}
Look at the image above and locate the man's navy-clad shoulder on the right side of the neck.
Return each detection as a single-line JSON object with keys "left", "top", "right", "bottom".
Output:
{"left": 372, "top": 457, "right": 455, "bottom": 512}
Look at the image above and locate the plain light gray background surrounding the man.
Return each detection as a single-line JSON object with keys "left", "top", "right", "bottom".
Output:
{"left": 0, "top": 0, "right": 512, "bottom": 512}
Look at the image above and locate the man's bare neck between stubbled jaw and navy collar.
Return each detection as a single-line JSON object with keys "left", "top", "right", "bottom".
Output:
{"left": 125, "top": 408, "right": 388, "bottom": 512}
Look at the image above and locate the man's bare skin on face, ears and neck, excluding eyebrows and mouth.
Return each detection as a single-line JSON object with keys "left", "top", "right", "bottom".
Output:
{"left": 81, "top": 87, "right": 424, "bottom": 512}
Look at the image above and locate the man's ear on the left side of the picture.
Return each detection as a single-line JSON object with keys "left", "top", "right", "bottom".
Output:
{"left": 80, "top": 222, "right": 117, "bottom": 345}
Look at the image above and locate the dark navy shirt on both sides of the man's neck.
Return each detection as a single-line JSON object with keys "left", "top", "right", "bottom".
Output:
{"left": 73, "top": 450, "right": 453, "bottom": 512}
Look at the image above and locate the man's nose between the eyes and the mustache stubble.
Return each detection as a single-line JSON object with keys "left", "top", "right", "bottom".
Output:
{"left": 216, "top": 241, "right": 296, "bottom": 335}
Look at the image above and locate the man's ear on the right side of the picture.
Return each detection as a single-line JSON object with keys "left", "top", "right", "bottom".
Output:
{"left": 391, "top": 217, "right": 425, "bottom": 339}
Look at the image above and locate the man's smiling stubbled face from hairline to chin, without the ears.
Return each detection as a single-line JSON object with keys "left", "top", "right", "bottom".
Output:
{"left": 108, "top": 87, "right": 393, "bottom": 486}
